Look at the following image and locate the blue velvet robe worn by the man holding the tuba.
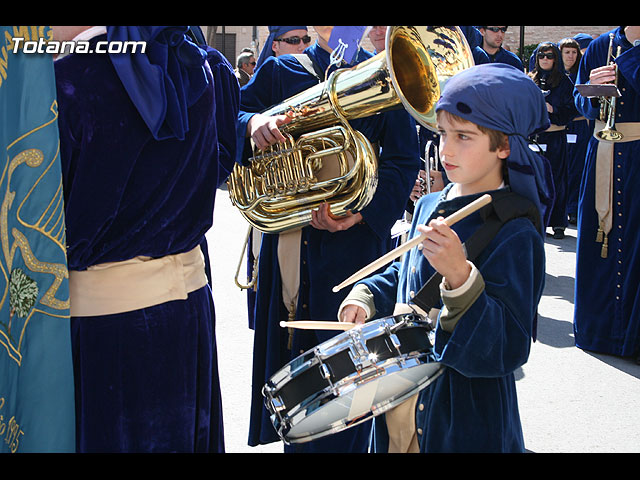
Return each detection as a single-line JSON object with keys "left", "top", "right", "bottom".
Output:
{"left": 238, "top": 44, "right": 420, "bottom": 452}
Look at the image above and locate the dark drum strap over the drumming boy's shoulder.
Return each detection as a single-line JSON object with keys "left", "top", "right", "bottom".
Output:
{"left": 411, "top": 191, "right": 541, "bottom": 312}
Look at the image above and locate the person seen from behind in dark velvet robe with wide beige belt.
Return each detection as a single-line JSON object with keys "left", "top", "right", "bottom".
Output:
{"left": 53, "top": 26, "right": 239, "bottom": 453}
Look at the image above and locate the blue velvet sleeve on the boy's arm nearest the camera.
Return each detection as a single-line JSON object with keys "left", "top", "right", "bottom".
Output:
{"left": 435, "top": 219, "right": 545, "bottom": 377}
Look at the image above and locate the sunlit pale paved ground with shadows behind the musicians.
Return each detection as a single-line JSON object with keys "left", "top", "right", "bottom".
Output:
{"left": 208, "top": 190, "right": 640, "bottom": 453}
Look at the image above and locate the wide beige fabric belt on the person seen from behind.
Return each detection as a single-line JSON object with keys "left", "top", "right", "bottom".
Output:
{"left": 69, "top": 246, "right": 207, "bottom": 317}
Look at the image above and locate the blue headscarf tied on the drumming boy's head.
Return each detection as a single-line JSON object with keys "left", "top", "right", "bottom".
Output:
{"left": 436, "top": 63, "right": 554, "bottom": 234}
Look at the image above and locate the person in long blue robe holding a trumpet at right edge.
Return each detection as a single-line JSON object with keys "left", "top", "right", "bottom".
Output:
{"left": 574, "top": 26, "right": 640, "bottom": 358}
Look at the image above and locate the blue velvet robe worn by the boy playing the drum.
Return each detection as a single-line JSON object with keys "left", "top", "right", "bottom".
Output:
{"left": 359, "top": 186, "right": 545, "bottom": 453}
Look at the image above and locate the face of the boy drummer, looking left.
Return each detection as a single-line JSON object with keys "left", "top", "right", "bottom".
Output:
{"left": 438, "top": 114, "right": 509, "bottom": 195}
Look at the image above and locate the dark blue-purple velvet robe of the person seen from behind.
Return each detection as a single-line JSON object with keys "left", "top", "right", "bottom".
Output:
{"left": 55, "top": 36, "right": 239, "bottom": 452}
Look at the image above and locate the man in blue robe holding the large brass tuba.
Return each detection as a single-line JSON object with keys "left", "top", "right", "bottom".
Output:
{"left": 238, "top": 26, "right": 420, "bottom": 452}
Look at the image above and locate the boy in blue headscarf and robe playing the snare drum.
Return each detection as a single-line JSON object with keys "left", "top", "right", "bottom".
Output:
{"left": 338, "top": 64, "right": 553, "bottom": 453}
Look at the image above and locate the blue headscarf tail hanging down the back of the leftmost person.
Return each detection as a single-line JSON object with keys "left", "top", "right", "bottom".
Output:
{"left": 107, "top": 26, "right": 208, "bottom": 140}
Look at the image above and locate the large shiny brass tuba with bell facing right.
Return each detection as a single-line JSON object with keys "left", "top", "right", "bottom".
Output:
{"left": 227, "top": 26, "right": 473, "bottom": 233}
